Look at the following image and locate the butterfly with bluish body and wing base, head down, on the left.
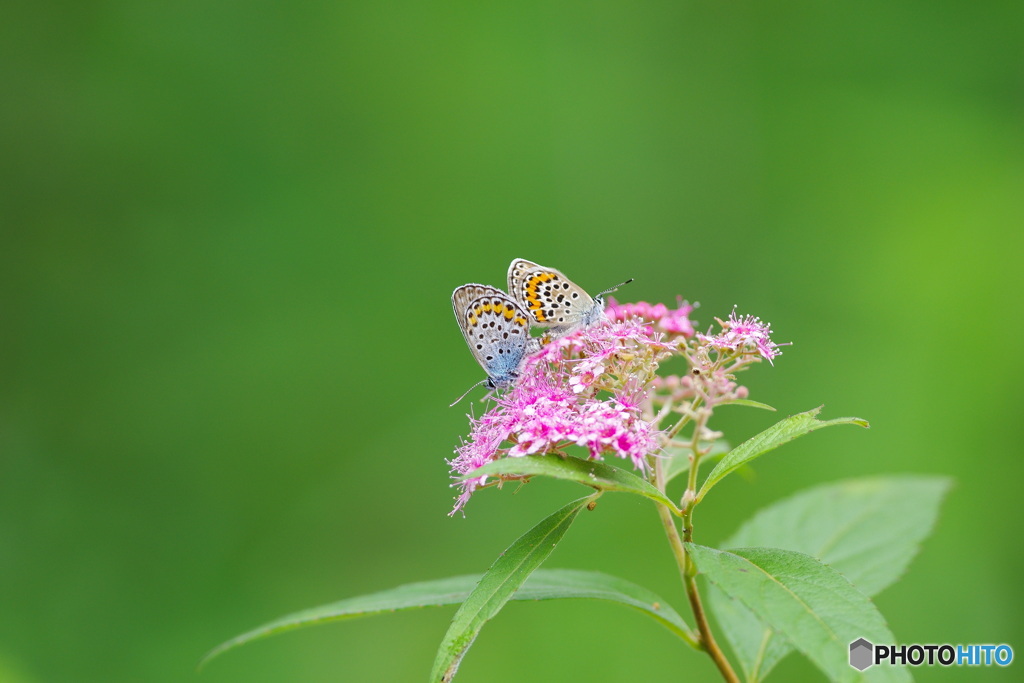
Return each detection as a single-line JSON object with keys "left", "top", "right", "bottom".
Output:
{"left": 452, "top": 284, "right": 539, "bottom": 405}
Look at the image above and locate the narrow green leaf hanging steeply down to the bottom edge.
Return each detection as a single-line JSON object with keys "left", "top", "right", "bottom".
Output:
{"left": 430, "top": 495, "right": 597, "bottom": 683}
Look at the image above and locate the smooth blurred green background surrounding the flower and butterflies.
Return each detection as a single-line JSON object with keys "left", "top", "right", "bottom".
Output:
{"left": 0, "top": 0, "right": 1024, "bottom": 683}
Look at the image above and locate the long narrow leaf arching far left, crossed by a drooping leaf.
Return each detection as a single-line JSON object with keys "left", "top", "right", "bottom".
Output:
{"left": 200, "top": 569, "right": 695, "bottom": 668}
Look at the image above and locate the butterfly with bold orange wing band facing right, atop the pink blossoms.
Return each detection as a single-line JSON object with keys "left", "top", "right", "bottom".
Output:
{"left": 508, "top": 258, "right": 633, "bottom": 337}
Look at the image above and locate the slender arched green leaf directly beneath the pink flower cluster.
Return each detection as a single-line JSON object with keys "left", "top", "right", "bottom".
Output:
{"left": 462, "top": 455, "right": 681, "bottom": 515}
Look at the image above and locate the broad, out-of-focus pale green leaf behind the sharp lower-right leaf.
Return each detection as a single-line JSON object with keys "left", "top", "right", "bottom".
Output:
{"left": 709, "top": 475, "right": 951, "bottom": 681}
